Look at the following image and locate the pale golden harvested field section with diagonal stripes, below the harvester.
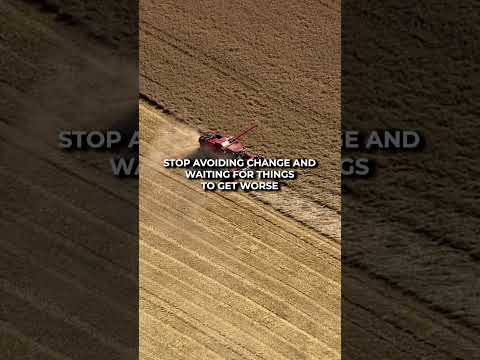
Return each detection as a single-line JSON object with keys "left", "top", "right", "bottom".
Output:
{"left": 140, "top": 103, "right": 340, "bottom": 359}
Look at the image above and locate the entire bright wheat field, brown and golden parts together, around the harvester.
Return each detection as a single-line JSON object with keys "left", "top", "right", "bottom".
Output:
{"left": 140, "top": 1, "right": 341, "bottom": 359}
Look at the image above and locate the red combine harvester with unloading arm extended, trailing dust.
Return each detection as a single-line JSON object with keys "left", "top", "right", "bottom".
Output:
{"left": 198, "top": 124, "right": 257, "bottom": 159}
